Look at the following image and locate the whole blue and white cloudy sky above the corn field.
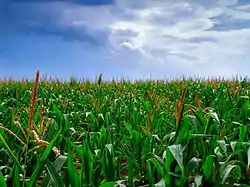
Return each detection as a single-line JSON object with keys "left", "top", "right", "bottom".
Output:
{"left": 0, "top": 0, "right": 250, "bottom": 79}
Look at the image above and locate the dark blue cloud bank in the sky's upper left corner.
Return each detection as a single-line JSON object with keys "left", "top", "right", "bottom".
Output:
{"left": 0, "top": 0, "right": 111, "bottom": 45}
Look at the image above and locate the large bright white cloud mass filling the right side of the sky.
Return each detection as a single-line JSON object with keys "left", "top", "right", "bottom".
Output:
{"left": 53, "top": 0, "right": 250, "bottom": 77}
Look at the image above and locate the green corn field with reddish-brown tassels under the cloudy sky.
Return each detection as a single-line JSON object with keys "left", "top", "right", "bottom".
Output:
{"left": 0, "top": 71, "right": 250, "bottom": 187}
